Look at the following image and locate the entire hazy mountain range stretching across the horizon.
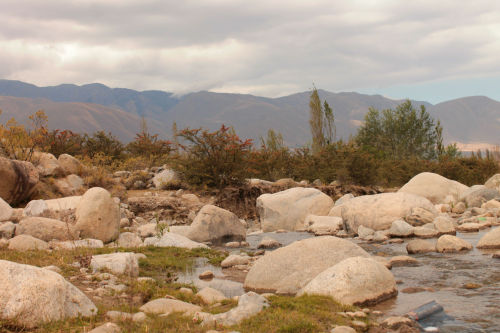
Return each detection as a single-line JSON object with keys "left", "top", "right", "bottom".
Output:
{"left": 0, "top": 80, "right": 500, "bottom": 148}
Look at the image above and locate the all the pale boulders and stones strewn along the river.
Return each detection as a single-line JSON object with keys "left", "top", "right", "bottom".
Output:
{"left": 0, "top": 158, "right": 500, "bottom": 327}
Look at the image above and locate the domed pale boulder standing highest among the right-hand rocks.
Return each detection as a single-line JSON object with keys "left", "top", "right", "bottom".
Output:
{"left": 398, "top": 172, "right": 468, "bottom": 204}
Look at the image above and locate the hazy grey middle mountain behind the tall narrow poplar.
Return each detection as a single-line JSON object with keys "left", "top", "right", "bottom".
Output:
{"left": 165, "top": 90, "right": 429, "bottom": 146}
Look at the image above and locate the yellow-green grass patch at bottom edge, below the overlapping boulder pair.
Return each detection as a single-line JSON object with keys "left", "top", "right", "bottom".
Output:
{"left": 233, "top": 295, "right": 362, "bottom": 333}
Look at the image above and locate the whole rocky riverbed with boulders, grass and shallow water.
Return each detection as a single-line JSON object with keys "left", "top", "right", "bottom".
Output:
{"left": 0, "top": 156, "right": 500, "bottom": 333}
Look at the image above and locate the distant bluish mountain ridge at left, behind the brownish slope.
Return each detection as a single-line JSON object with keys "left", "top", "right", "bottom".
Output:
{"left": 0, "top": 80, "right": 178, "bottom": 119}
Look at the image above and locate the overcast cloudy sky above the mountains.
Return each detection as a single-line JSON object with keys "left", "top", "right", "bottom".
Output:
{"left": 0, "top": 0, "right": 500, "bottom": 102}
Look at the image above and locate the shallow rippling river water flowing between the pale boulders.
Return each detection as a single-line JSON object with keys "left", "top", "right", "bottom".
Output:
{"left": 178, "top": 229, "right": 500, "bottom": 333}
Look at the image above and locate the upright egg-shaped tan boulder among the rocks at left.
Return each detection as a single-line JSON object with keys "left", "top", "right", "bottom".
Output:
{"left": 75, "top": 187, "right": 120, "bottom": 243}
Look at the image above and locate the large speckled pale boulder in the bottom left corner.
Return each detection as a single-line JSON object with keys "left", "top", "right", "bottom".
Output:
{"left": 0, "top": 260, "right": 97, "bottom": 328}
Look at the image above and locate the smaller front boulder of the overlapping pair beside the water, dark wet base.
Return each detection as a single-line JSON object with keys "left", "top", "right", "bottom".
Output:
{"left": 299, "top": 257, "right": 397, "bottom": 305}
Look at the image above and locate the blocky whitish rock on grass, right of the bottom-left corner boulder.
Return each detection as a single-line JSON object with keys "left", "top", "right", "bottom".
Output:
{"left": 90, "top": 252, "right": 139, "bottom": 276}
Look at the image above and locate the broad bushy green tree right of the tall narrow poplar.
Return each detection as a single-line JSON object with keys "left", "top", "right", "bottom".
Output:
{"left": 356, "top": 100, "right": 446, "bottom": 159}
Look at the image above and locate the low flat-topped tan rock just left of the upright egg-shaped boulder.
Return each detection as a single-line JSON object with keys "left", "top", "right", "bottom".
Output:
{"left": 16, "top": 217, "right": 78, "bottom": 242}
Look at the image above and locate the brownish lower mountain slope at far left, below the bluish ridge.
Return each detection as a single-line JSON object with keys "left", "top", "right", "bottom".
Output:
{"left": 0, "top": 96, "right": 162, "bottom": 142}
